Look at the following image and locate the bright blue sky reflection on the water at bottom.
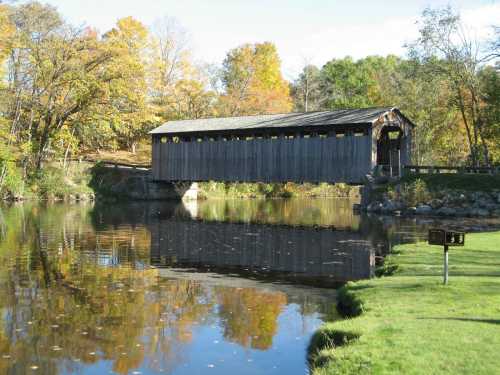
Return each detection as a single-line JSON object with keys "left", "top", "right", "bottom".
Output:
{"left": 72, "top": 296, "right": 322, "bottom": 375}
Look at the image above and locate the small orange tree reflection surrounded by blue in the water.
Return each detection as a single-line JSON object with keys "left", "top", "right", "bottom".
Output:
{"left": 216, "top": 288, "right": 287, "bottom": 350}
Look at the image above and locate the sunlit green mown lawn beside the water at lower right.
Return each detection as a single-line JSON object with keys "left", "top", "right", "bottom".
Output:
{"left": 310, "top": 232, "right": 500, "bottom": 375}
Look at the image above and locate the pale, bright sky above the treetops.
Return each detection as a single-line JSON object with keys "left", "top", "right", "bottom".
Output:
{"left": 28, "top": 0, "right": 500, "bottom": 80}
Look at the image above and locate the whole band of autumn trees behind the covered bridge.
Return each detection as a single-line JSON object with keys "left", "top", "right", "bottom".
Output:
{"left": 0, "top": 2, "right": 500, "bottom": 197}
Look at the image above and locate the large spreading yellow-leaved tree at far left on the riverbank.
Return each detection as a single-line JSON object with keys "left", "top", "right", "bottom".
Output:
{"left": 4, "top": 2, "right": 118, "bottom": 170}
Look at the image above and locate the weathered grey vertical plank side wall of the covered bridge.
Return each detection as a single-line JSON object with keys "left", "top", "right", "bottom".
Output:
{"left": 153, "top": 134, "right": 372, "bottom": 183}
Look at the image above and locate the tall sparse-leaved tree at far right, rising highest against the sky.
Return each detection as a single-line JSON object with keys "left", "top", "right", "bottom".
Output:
{"left": 410, "top": 7, "right": 490, "bottom": 166}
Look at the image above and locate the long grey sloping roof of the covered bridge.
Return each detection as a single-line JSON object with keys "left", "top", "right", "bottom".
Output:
{"left": 150, "top": 107, "right": 410, "bottom": 134}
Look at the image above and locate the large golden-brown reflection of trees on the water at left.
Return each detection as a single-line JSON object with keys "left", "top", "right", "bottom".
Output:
{"left": 0, "top": 206, "right": 212, "bottom": 374}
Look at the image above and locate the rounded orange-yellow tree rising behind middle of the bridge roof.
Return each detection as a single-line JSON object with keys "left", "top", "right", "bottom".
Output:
{"left": 221, "top": 42, "right": 292, "bottom": 116}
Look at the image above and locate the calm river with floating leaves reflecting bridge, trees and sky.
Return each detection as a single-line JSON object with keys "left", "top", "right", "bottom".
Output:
{"left": 0, "top": 199, "right": 492, "bottom": 375}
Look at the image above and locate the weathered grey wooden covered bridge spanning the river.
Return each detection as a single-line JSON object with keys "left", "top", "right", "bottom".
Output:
{"left": 151, "top": 108, "right": 413, "bottom": 183}
